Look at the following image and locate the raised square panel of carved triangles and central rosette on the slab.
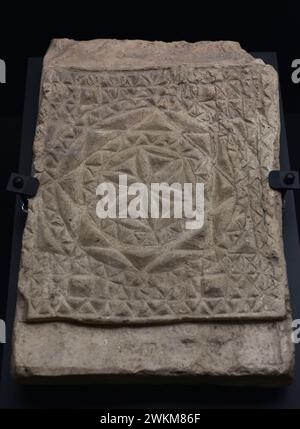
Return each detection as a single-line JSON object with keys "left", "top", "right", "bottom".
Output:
{"left": 19, "top": 64, "right": 286, "bottom": 324}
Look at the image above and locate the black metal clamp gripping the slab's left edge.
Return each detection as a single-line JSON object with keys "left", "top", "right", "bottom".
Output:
{"left": 6, "top": 173, "right": 40, "bottom": 213}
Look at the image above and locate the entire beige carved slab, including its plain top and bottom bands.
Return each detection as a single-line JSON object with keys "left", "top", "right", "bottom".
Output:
{"left": 14, "top": 40, "right": 293, "bottom": 384}
